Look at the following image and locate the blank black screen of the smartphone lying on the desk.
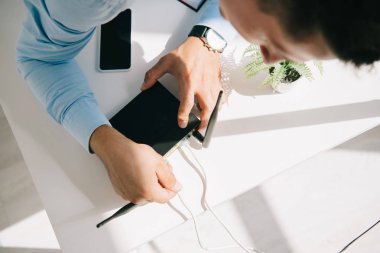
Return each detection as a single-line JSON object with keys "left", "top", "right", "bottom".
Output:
{"left": 99, "top": 9, "right": 132, "bottom": 71}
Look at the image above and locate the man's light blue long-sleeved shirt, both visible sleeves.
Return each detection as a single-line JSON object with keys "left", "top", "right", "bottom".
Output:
{"left": 16, "top": 0, "right": 235, "bottom": 150}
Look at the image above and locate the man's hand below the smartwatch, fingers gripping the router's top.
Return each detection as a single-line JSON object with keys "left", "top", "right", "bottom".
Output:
{"left": 141, "top": 37, "right": 222, "bottom": 129}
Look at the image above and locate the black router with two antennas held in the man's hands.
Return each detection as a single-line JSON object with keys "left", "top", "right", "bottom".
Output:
{"left": 96, "top": 82, "right": 223, "bottom": 228}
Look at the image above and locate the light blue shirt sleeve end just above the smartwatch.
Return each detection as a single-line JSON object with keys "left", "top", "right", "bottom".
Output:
{"left": 198, "top": 0, "right": 237, "bottom": 42}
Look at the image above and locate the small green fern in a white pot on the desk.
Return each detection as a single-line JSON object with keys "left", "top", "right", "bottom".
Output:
{"left": 244, "top": 44, "right": 323, "bottom": 93}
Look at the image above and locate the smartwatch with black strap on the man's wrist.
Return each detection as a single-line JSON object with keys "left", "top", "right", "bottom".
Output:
{"left": 189, "top": 25, "right": 227, "bottom": 53}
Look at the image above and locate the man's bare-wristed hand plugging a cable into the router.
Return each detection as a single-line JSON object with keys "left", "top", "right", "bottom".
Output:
{"left": 90, "top": 126, "right": 181, "bottom": 204}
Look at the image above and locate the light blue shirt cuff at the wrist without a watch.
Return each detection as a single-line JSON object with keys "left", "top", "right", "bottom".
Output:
{"left": 62, "top": 99, "right": 111, "bottom": 153}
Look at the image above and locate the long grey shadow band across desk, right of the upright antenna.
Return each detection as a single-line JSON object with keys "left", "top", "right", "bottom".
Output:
{"left": 214, "top": 100, "right": 380, "bottom": 137}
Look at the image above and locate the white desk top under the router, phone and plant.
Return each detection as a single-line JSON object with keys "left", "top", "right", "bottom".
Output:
{"left": 0, "top": 0, "right": 380, "bottom": 253}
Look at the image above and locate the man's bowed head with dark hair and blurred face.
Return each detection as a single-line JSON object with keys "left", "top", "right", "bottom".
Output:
{"left": 220, "top": 0, "right": 380, "bottom": 66}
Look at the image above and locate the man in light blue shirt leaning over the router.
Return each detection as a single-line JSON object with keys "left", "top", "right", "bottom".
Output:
{"left": 17, "top": 0, "right": 380, "bottom": 203}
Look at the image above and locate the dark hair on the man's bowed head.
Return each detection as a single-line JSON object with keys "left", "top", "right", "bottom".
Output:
{"left": 258, "top": 0, "right": 380, "bottom": 66}
